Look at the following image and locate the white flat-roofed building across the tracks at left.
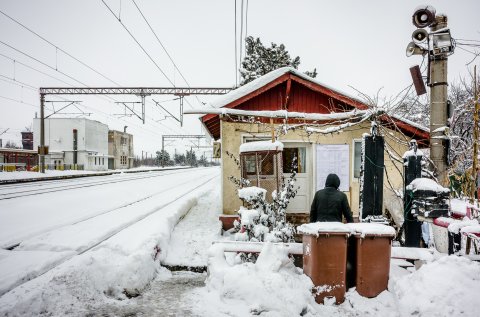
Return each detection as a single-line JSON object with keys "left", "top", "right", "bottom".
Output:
{"left": 33, "top": 118, "right": 108, "bottom": 171}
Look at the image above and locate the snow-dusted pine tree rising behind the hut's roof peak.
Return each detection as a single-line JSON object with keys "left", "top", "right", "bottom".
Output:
{"left": 240, "top": 36, "right": 317, "bottom": 85}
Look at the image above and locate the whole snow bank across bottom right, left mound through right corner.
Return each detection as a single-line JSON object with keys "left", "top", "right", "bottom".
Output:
{"left": 196, "top": 243, "right": 480, "bottom": 317}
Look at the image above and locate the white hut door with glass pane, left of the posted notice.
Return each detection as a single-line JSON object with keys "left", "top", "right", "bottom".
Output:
{"left": 282, "top": 143, "right": 312, "bottom": 213}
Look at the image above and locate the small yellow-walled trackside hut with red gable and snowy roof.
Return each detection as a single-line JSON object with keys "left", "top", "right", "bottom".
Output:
{"left": 193, "top": 67, "right": 429, "bottom": 224}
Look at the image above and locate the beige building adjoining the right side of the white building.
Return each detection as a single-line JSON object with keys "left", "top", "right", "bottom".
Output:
{"left": 108, "top": 127, "right": 134, "bottom": 169}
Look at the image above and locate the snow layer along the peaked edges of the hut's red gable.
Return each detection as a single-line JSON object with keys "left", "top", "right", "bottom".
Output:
{"left": 210, "top": 67, "right": 363, "bottom": 108}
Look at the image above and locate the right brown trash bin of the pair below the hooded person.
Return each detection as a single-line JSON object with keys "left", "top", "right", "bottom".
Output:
{"left": 350, "top": 227, "right": 393, "bottom": 297}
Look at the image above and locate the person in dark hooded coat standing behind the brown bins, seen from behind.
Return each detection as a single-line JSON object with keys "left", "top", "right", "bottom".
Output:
{"left": 310, "top": 174, "right": 353, "bottom": 222}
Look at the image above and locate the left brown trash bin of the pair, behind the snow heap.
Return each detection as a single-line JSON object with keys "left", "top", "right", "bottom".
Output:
{"left": 302, "top": 232, "right": 348, "bottom": 304}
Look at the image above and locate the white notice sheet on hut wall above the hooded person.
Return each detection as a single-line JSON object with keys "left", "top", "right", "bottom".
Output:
{"left": 316, "top": 144, "right": 350, "bottom": 192}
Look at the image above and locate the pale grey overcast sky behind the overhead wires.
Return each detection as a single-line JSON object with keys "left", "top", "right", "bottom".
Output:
{"left": 0, "top": 0, "right": 480, "bottom": 155}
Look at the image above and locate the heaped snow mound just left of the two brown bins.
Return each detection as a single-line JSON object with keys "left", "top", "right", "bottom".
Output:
{"left": 197, "top": 243, "right": 315, "bottom": 316}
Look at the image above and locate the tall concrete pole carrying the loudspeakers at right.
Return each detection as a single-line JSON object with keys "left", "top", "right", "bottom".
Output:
{"left": 428, "top": 15, "right": 448, "bottom": 187}
